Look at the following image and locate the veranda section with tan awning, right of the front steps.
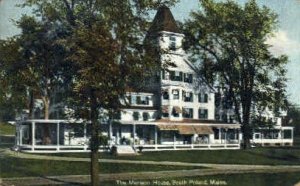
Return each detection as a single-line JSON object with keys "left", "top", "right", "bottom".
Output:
{"left": 115, "top": 122, "right": 241, "bottom": 151}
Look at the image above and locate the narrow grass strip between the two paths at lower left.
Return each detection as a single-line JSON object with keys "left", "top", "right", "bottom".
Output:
{"left": 0, "top": 157, "right": 200, "bottom": 178}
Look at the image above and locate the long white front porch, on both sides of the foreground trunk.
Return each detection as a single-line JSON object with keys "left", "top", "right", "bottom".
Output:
{"left": 15, "top": 120, "right": 241, "bottom": 153}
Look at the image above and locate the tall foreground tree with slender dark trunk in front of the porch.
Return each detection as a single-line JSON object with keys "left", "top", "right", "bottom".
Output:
{"left": 21, "top": 0, "right": 176, "bottom": 185}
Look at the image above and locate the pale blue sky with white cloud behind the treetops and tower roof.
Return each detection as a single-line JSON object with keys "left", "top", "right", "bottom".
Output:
{"left": 0, "top": 0, "right": 300, "bottom": 105}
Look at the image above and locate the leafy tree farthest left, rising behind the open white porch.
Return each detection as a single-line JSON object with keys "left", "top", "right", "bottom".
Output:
{"left": 1, "top": 15, "right": 71, "bottom": 144}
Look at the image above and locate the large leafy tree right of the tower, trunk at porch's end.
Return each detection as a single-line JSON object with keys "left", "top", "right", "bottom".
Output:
{"left": 184, "top": 0, "right": 288, "bottom": 148}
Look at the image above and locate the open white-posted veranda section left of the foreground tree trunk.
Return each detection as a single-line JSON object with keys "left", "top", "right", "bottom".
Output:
{"left": 15, "top": 120, "right": 107, "bottom": 153}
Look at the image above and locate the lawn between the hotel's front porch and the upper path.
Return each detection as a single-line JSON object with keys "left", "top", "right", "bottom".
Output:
{"left": 49, "top": 147, "right": 300, "bottom": 165}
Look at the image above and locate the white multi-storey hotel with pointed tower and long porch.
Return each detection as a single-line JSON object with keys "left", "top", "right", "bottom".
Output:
{"left": 16, "top": 7, "right": 262, "bottom": 152}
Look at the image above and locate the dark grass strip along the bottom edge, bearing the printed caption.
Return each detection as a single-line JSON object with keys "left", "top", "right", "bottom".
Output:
{"left": 102, "top": 172, "right": 300, "bottom": 186}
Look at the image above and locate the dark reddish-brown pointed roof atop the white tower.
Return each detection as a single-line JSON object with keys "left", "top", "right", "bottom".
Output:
{"left": 149, "top": 6, "right": 180, "bottom": 33}
